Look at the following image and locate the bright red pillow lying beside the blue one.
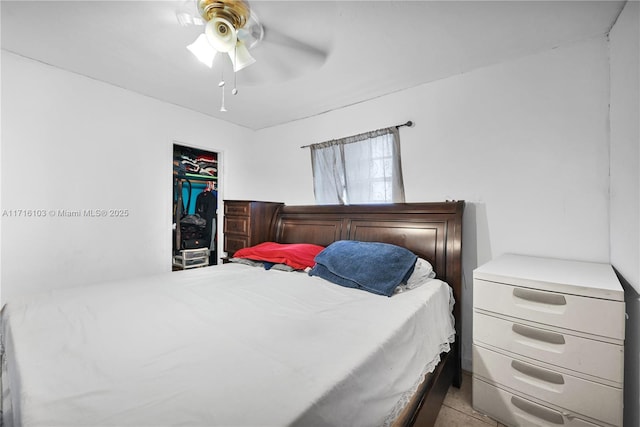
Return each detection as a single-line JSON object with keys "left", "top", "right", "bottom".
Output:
{"left": 233, "top": 242, "right": 324, "bottom": 270}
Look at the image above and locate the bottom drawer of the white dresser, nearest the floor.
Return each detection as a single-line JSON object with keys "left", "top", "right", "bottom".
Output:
{"left": 472, "top": 377, "right": 596, "bottom": 427}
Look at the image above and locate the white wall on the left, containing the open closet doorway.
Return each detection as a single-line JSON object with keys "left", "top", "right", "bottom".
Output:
{"left": 1, "top": 51, "right": 253, "bottom": 300}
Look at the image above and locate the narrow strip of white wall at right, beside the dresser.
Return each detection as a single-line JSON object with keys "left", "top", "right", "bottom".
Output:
{"left": 609, "top": 1, "right": 640, "bottom": 426}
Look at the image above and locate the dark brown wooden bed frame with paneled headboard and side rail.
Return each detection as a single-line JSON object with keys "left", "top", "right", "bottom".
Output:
{"left": 265, "top": 201, "right": 464, "bottom": 426}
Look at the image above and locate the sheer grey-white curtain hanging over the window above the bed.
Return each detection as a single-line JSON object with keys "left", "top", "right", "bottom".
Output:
{"left": 310, "top": 127, "right": 405, "bottom": 205}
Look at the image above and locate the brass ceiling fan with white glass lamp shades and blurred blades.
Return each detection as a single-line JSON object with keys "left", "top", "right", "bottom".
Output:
{"left": 176, "top": 0, "right": 327, "bottom": 111}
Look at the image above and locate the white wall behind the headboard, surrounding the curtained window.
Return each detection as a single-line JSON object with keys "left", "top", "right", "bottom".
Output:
{"left": 252, "top": 37, "right": 609, "bottom": 369}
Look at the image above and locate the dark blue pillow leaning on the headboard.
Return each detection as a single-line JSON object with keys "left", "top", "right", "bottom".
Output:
{"left": 309, "top": 240, "right": 418, "bottom": 296}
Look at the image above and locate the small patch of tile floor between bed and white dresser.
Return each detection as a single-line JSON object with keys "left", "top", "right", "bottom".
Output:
{"left": 435, "top": 372, "right": 505, "bottom": 427}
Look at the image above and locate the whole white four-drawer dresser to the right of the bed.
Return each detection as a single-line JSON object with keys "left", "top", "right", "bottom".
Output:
{"left": 473, "top": 254, "right": 625, "bottom": 427}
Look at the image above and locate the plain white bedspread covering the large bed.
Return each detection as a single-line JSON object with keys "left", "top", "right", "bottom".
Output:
{"left": 2, "top": 264, "right": 454, "bottom": 426}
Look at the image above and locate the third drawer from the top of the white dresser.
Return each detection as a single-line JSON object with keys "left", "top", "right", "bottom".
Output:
{"left": 473, "top": 344, "right": 622, "bottom": 425}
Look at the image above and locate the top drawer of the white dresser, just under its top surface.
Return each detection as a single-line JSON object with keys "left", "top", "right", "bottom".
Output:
{"left": 473, "top": 279, "right": 624, "bottom": 341}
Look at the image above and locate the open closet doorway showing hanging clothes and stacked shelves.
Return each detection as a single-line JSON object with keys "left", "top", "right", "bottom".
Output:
{"left": 172, "top": 144, "right": 219, "bottom": 271}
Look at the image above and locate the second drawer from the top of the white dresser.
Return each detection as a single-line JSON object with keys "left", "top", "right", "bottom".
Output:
{"left": 473, "top": 312, "right": 624, "bottom": 385}
